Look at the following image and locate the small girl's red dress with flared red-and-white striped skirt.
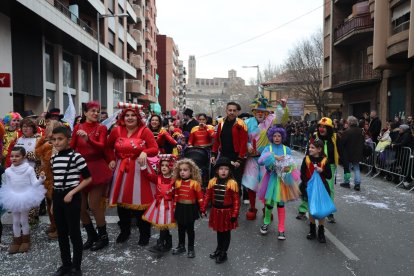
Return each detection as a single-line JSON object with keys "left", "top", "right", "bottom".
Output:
{"left": 142, "top": 170, "right": 176, "bottom": 230}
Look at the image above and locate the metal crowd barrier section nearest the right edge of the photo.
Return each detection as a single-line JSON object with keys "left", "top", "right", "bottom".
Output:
{"left": 372, "top": 147, "right": 411, "bottom": 187}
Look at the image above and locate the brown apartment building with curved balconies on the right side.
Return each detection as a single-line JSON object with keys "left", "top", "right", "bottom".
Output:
{"left": 323, "top": 0, "right": 414, "bottom": 121}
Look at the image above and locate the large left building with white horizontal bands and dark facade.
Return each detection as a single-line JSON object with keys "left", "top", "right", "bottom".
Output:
{"left": 0, "top": 0, "right": 141, "bottom": 116}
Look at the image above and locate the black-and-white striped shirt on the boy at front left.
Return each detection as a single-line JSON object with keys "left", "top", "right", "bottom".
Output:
{"left": 50, "top": 149, "right": 91, "bottom": 189}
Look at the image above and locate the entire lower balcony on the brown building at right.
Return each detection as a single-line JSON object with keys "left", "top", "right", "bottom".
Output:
{"left": 327, "top": 64, "right": 381, "bottom": 91}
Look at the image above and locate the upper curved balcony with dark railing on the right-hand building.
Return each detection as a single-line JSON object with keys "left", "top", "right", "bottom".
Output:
{"left": 334, "top": 13, "right": 374, "bottom": 46}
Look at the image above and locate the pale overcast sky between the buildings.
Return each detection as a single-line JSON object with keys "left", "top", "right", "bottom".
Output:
{"left": 156, "top": 0, "right": 324, "bottom": 83}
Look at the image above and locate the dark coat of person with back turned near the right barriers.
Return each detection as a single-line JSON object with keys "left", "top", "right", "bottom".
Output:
{"left": 341, "top": 126, "right": 365, "bottom": 163}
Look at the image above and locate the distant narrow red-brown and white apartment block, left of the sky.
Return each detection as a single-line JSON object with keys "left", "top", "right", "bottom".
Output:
{"left": 157, "top": 35, "right": 180, "bottom": 111}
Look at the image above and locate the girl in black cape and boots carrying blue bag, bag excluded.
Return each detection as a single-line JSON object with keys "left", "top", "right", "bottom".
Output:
{"left": 300, "top": 139, "right": 332, "bottom": 243}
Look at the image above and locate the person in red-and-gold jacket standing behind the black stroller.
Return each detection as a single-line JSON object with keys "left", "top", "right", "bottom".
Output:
{"left": 188, "top": 113, "right": 214, "bottom": 148}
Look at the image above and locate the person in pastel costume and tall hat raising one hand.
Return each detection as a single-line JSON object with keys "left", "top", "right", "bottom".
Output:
{"left": 242, "top": 95, "right": 286, "bottom": 220}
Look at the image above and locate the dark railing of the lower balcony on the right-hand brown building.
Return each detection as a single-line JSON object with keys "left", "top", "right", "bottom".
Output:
{"left": 332, "top": 64, "right": 381, "bottom": 85}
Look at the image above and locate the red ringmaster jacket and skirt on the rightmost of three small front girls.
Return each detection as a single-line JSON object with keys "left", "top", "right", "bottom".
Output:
{"left": 202, "top": 177, "right": 240, "bottom": 232}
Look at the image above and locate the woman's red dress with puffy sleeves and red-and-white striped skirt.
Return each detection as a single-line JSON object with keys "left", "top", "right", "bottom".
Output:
{"left": 108, "top": 126, "right": 158, "bottom": 210}
